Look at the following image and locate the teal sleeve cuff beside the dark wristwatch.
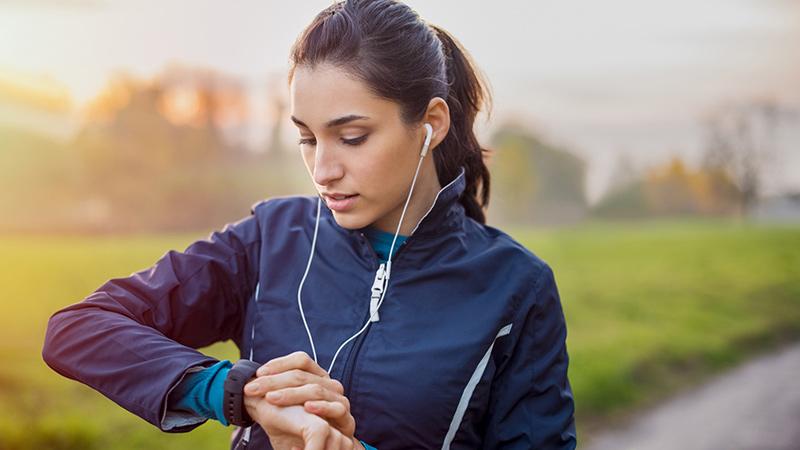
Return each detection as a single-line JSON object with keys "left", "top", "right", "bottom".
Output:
{"left": 168, "top": 360, "right": 233, "bottom": 426}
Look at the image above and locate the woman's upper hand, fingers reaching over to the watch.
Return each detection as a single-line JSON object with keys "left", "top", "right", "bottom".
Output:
{"left": 244, "top": 352, "right": 361, "bottom": 448}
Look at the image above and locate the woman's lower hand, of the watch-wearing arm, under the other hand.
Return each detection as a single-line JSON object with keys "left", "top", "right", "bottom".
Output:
{"left": 244, "top": 396, "right": 363, "bottom": 450}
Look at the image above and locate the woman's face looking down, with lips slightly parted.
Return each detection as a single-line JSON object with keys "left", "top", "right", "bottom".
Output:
{"left": 290, "top": 64, "right": 438, "bottom": 233}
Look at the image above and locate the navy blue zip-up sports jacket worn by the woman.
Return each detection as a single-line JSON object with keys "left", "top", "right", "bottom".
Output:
{"left": 42, "top": 170, "right": 576, "bottom": 450}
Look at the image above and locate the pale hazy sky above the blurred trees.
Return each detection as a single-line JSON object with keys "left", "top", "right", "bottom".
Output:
{"left": 0, "top": 0, "right": 800, "bottom": 200}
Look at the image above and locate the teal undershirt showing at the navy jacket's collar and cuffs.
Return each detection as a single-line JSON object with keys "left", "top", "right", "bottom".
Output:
{"left": 168, "top": 227, "right": 408, "bottom": 450}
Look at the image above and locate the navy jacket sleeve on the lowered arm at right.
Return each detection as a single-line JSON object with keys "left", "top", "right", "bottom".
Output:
{"left": 483, "top": 264, "right": 576, "bottom": 449}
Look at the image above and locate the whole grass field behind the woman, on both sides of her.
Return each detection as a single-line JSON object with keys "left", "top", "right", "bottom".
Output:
{"left": 0, "top": 221, "right": 800, "bottom": 450}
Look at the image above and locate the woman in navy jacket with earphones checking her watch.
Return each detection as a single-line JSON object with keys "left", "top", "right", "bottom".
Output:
{"left": 43, "top": 0, "right": 575, "bottom": 450}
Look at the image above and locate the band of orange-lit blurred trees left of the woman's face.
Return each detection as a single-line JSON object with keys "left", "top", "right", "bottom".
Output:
{"left": 0, "top": 66, "right": 313, "bottom": 232}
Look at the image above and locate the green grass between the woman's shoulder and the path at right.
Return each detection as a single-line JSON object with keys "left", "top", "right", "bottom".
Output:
{"left": 512, "top": 220, "right": 800, "bottom": 432}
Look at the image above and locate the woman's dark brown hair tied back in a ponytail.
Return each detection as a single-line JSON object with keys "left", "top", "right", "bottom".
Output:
{"left": 289, "top": 0, "right": 491, "bottom": 223}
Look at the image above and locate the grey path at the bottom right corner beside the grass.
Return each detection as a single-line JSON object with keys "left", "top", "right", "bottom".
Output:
{"left": 581, "top": 344, "right": 800, "bottom": 450}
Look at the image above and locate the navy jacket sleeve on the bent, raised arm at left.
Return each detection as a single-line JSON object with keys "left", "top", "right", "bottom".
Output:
{"left": 42, "top": 206, "right": 261, "bottom": 432}
